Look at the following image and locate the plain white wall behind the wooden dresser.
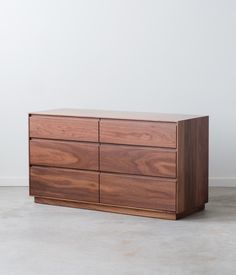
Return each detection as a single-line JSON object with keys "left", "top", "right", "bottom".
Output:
{"left": 0, "top": 0, "right": 236, "bottom": 188}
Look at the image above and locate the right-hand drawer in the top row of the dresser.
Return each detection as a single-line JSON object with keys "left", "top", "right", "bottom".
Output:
{"left": 100, "top": 119, "right": 176, "bottom": 148}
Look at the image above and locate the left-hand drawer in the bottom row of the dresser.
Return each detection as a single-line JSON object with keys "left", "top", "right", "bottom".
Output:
{"left": 30, "top": 166, "right": 99, "bottom": 202}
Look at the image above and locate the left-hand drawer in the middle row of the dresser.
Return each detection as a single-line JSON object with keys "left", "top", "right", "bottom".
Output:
{"left": 30, "top": 139, "right": 98, "bottom": 170}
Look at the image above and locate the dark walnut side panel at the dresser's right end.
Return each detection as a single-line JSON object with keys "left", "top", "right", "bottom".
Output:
{"left": 177, "top": 117, "right": 209, "bottom": 213}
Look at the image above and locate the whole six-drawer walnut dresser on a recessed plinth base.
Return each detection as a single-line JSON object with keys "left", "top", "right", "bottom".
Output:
{"left": 29, "top": 109, "right": 208, "bottom": 220}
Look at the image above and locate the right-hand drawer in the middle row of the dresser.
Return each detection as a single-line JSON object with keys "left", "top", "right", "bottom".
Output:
{"left": 100, "top": 144, "right": 176, "bottom": 178}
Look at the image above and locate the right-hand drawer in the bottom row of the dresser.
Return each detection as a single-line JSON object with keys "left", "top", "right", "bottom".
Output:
{"left": 100, "top": 173, "right": 176, "bottom": 211}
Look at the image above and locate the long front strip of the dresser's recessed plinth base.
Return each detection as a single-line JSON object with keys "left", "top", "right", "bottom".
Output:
{"left": 35, "top": 197, "right": 178, "bottom": 220}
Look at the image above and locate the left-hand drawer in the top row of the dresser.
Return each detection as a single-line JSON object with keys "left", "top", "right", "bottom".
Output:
{"left": 30, "top": 115, "right": 98, "bottom": 142}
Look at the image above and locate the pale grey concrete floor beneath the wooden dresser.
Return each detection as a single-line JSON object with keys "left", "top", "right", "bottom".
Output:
{"left": 0, "top": 187, "right": 236, "bottom": 275}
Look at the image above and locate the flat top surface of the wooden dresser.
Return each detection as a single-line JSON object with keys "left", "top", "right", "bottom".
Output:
{"left": 30, "top": 109, "right": 208, "bottom": 122}
